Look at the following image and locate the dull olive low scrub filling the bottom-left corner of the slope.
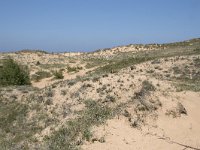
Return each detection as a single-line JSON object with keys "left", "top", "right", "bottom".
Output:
{"left": 0, "top": 93, "right": 47, "bottom": 149}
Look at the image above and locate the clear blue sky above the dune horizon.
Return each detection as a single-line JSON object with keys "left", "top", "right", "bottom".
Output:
{"left": 0, "top": 0, "right": 200, "bottom": 52}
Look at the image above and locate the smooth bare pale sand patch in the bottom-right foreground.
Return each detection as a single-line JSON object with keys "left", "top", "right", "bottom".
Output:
{"left": 82, "top": 92, "right": 200, "bottom": 150}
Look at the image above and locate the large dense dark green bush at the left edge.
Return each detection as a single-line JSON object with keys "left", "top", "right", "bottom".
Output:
{"left": 0, "top": 59, "right": 30, "bottom": 86}
